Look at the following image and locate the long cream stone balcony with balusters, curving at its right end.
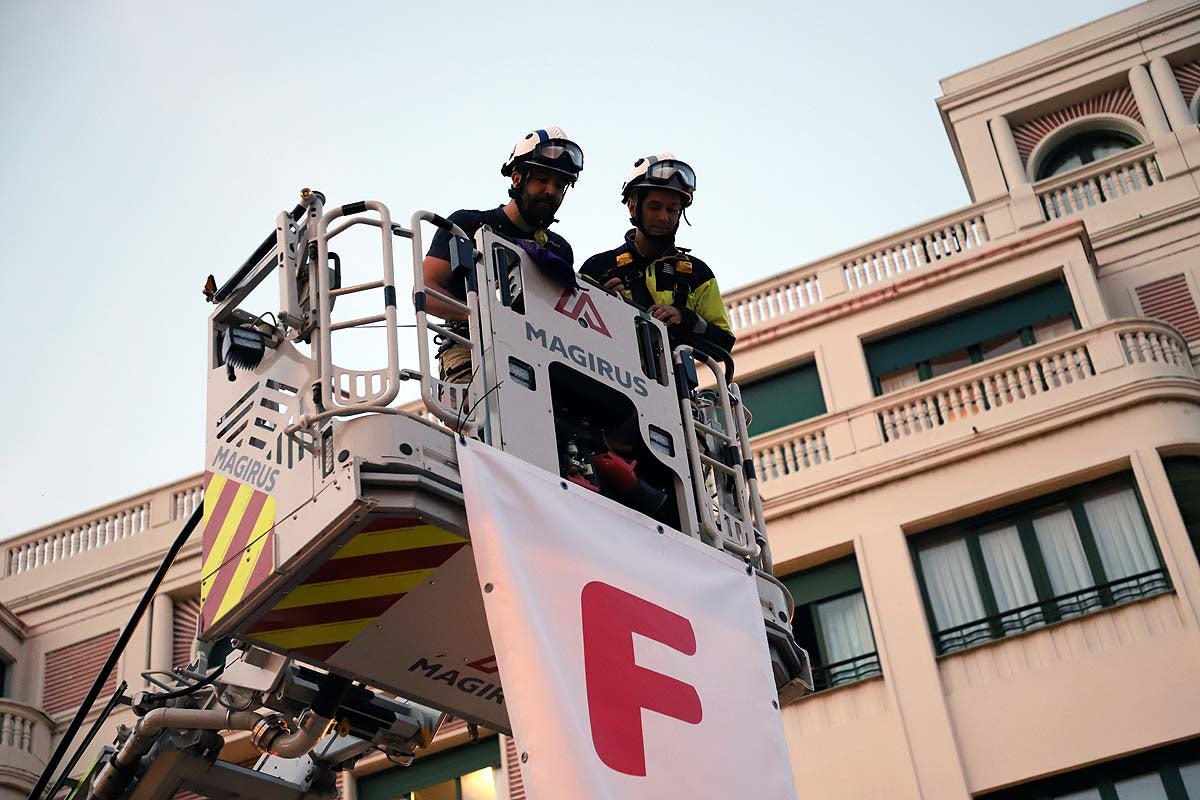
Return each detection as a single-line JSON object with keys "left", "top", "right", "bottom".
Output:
{"left": 751, "top": 319, "right": 1200, "bottom": 498}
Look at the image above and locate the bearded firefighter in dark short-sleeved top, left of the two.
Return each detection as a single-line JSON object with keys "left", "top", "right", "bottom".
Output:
{"left": 421, "top": 126, "right": 583, "bottom": 383}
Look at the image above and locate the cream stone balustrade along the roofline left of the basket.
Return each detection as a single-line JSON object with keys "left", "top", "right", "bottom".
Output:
{"left": 0, "top": 475, "right": 203, "bottom": 578}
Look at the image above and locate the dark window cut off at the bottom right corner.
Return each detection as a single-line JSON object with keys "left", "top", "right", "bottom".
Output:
{"left": 979, "top": 740, "right": 1200, "bottom": 800}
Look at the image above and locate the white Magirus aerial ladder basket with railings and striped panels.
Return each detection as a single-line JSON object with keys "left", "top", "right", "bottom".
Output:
{"left": 200, "top": 193, "right": 811, "bottom": 732}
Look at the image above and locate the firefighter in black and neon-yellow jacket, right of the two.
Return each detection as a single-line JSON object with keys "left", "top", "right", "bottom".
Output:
{"left": 580, "top": 152, "right": 733, "bottom": 353}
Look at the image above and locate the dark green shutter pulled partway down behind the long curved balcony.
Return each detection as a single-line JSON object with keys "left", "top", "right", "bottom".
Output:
{"left": 863, "top": 281, "right": 1075, "bottom": 377}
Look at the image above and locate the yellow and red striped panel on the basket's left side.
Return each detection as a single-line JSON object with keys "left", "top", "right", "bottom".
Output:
{"left": 200, "top": 471, "right": 275, "bottom": 631}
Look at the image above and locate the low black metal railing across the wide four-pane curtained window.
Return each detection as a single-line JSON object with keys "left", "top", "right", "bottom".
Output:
{"left": 926, "top": 569, "right": 1171, "bottom": 652}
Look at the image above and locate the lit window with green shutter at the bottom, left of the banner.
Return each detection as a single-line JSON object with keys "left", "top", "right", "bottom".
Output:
{"left": 359, "top": 736, "right": 503, "bottom": 800}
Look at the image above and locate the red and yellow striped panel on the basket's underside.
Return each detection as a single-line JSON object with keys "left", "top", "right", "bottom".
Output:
{"left": 246, "top": 517, "right": 467, "bottom": 661}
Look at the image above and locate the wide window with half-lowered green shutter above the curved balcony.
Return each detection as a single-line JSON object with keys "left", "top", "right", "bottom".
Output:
{"left": 863, "top": 281, "right": 1079, "bottom": 395}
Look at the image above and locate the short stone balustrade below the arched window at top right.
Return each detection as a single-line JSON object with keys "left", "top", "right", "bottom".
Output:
{"left": 1033, "top": 144, "right": 1163, "bottom": 222}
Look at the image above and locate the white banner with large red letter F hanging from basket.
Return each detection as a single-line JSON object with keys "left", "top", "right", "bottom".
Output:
{"left": 458, "top": 434, "right": 796, "bottom": 800}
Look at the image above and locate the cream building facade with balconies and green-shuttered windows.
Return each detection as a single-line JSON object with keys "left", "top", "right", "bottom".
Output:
{"left": 0, "top": 0, "right": 1200, "bottom": 800}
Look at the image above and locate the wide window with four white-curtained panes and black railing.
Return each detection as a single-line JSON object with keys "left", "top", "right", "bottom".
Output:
{"left": 913, "top": 474, "right": 1170, "bottom": 655}
